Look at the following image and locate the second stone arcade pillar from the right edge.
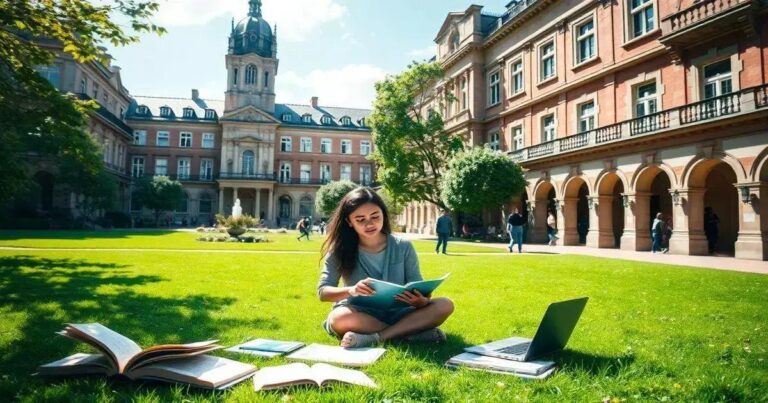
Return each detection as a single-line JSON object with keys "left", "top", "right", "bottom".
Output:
{"left": 669, "top": 188, "right": 709, "bottom": 255}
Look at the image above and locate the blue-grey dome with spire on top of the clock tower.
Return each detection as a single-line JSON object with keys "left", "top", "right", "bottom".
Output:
{"left": 229, "top": 0, "right": 277, "bottom": 57}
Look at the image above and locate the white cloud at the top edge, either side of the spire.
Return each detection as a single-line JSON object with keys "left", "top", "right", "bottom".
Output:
{"left": 155, "top": 0, "right": 347, "bottom": 42}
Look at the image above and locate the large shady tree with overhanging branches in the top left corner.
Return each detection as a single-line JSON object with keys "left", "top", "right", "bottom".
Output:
{"left": 0, "top": 0, "right": 165, "bottom": 201}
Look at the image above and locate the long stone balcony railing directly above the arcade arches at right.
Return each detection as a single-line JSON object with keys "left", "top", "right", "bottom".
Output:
{"left": 509, "top": 85, "right": 768, "bottom": 162}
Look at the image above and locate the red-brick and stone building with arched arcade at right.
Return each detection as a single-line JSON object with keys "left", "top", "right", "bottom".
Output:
{"left": 404, "top": 0, "right": 768, "bottom": 260}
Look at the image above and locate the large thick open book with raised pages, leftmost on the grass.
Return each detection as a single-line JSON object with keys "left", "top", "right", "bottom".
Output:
{"left": 38, "top": 323, "right": 256, "bottom": 389}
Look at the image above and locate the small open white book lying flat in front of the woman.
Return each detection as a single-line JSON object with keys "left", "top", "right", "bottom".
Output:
{"left": 253, "top": 363, "right": 377, "bottom": 391}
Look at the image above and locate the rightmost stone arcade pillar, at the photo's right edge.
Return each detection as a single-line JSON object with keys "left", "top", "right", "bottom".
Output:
{"left": 736, "top": 182, "right": 768, "bottom": 260}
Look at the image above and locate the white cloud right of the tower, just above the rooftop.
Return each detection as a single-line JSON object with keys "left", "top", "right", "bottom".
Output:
{"left": 277, "top": 64, "right": 387, "bottom": 108}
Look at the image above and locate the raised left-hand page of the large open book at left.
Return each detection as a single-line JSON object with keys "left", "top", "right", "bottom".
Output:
{"left": 64, "top": 323, "right": 141, "bottom": 374}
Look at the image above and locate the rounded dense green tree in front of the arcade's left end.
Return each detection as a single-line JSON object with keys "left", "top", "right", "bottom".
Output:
{"left": 441, "top": 147, "right": 525, "bottom": 213}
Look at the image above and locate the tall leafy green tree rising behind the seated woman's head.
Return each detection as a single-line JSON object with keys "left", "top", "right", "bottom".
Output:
{"left": 368, "top": 62, "right": 463, "bottom": 207}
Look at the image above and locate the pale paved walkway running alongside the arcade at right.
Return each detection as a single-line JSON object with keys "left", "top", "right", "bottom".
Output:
{"left": 397, "top": 234, "right": 768, "bottom": 274}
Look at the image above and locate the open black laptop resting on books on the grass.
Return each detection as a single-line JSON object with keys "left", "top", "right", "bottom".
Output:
{"left": 464, "top": 297, "right": 588, "bottom": 361}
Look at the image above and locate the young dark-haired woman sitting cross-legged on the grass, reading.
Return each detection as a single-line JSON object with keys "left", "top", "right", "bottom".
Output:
{"left": 317, "top": 188, "right": 453, "bottom": 348}
